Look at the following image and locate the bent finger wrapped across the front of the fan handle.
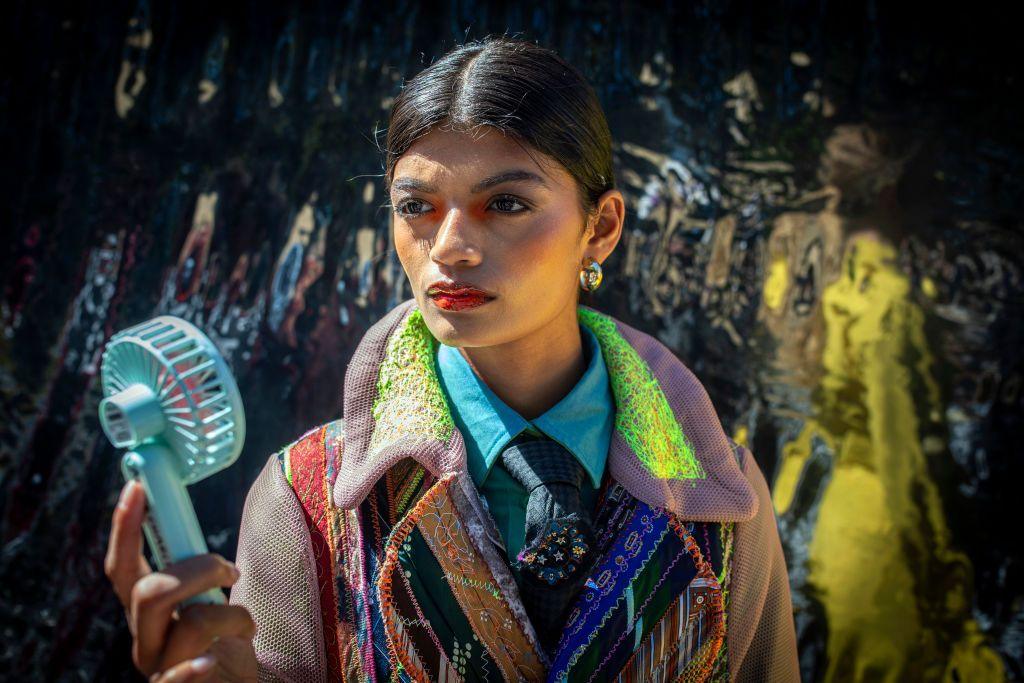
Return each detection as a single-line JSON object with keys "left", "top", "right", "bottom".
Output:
{"left": 131, "top": 553, "right": 239, "bottom": 673}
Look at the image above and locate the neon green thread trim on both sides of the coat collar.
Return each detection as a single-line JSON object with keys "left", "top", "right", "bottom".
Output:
{"left": 370, "top": 307, "right": 706, "bottom": 479}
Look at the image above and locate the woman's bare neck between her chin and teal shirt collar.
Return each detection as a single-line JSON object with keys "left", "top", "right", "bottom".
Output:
{"left": 460, "top": 301, "right": 586, "bottom": 420}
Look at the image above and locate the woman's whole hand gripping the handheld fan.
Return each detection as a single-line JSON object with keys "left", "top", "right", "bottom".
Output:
{"left": 103, "top": 481, "right": 256, "bottom": 683}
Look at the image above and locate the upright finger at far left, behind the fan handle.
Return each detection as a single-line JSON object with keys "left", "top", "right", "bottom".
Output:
{"left": 103, "top": 480, "right": 150, "bottom": 607}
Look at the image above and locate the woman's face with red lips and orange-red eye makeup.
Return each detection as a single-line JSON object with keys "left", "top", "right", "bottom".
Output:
{"left": 391, "top": 128, "right": 602, "bottom": 347}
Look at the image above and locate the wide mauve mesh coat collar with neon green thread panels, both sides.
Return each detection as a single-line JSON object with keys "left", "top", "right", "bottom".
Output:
{"left": 334, "top": 299, "right": 758, "bottom": 521}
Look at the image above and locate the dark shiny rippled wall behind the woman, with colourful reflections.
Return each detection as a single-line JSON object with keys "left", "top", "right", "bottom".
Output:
{"left": 0, "top": 0, "right": 1024, "bottom": 681}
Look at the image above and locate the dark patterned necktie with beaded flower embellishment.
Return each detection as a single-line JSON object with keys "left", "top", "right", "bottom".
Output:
{"left": 501, "top": 434, "right": 594, "bottom": 652}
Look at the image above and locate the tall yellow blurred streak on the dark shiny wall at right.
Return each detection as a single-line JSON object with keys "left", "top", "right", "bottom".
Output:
{"left": 765, "top": 233, "right": 1005, "bottom": 681}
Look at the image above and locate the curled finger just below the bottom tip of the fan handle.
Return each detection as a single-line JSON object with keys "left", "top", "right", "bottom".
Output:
{"left": 161, "top": 604, "right": 256, "bottom": 668}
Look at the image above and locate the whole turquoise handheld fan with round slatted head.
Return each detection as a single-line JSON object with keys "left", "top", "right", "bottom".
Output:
{"left": 99, "top": 315, "right": 246, "bottom": 603}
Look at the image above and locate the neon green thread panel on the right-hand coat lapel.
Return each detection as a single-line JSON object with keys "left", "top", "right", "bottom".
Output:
{"left": 579, "top": 307, "right": 705, "bottom": 479}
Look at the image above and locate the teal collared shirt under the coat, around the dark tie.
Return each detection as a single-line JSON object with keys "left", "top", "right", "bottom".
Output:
{"left": 437, "top": 325, "right": 615, "bottom": 558}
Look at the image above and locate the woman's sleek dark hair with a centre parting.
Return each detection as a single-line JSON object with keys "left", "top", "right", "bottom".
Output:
{"left": 384, "top": 36, "right": 615, "bottom": 220}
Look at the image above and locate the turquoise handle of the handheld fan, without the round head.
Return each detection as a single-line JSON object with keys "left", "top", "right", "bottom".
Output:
{"left": 121, "top": 440, "right": 224, "bottom": 605}
